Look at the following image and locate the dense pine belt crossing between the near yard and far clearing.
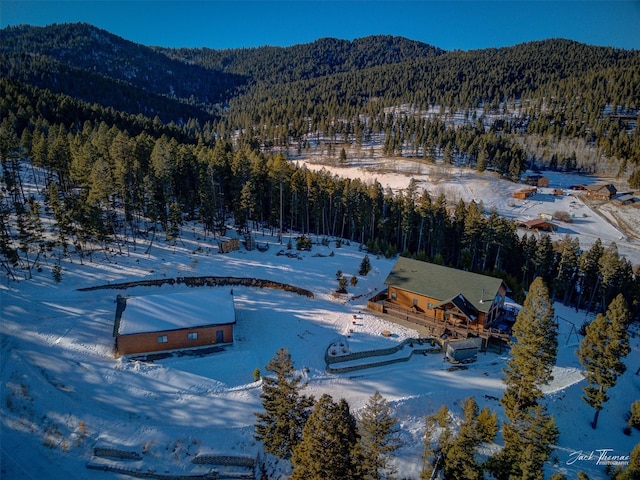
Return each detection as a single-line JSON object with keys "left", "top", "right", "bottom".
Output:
{"left": 0, "top": 82, "right": 640, "bottom": 316}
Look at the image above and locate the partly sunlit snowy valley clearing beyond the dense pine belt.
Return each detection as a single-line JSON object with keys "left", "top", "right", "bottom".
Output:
{"left": 299, "top": 148, "right": 640, "bottom": 265}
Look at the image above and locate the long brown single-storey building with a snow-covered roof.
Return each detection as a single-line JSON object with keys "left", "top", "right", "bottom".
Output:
{"left": 114, "top": 288, "right": 236, "bottom": 355}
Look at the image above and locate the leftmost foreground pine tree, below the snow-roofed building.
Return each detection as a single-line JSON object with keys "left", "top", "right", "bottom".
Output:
{"left": 255, "top": 348, "right": 313, "bottom": 459}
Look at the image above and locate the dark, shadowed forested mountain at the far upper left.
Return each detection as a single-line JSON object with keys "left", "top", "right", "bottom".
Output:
{"left": 0, "top": 23, "right": 245, "bottom": 122}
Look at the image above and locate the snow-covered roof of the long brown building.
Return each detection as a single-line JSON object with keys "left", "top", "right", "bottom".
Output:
{"left": 118, "top": 288, "right": 235, "bottom": 335}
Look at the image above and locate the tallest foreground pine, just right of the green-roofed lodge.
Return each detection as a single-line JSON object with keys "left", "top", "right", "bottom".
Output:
{"left": 492, "top": 277, "right": 558, "bottom": 480}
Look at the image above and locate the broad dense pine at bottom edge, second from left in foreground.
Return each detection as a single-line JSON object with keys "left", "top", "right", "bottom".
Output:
{"left": 291, "top": 394, "right": 361, "bottom": 480}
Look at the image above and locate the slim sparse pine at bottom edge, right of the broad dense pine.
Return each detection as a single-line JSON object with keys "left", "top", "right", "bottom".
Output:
{"left": 358, "top": 391, "right": 400, "bottom": 480}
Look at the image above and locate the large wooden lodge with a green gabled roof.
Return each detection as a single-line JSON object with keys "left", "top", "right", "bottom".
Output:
{"left": 385, "top": 257, "right": 507, "bottom": 332}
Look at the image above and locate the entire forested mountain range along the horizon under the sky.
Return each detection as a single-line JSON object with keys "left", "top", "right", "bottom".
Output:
{"left": 0, "top": 24, "right": 640, "bottom": 152}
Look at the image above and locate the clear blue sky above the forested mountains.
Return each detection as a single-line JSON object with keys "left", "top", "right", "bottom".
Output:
{"left": 0, "top": 0, "right": 640, "bottom": 50}
